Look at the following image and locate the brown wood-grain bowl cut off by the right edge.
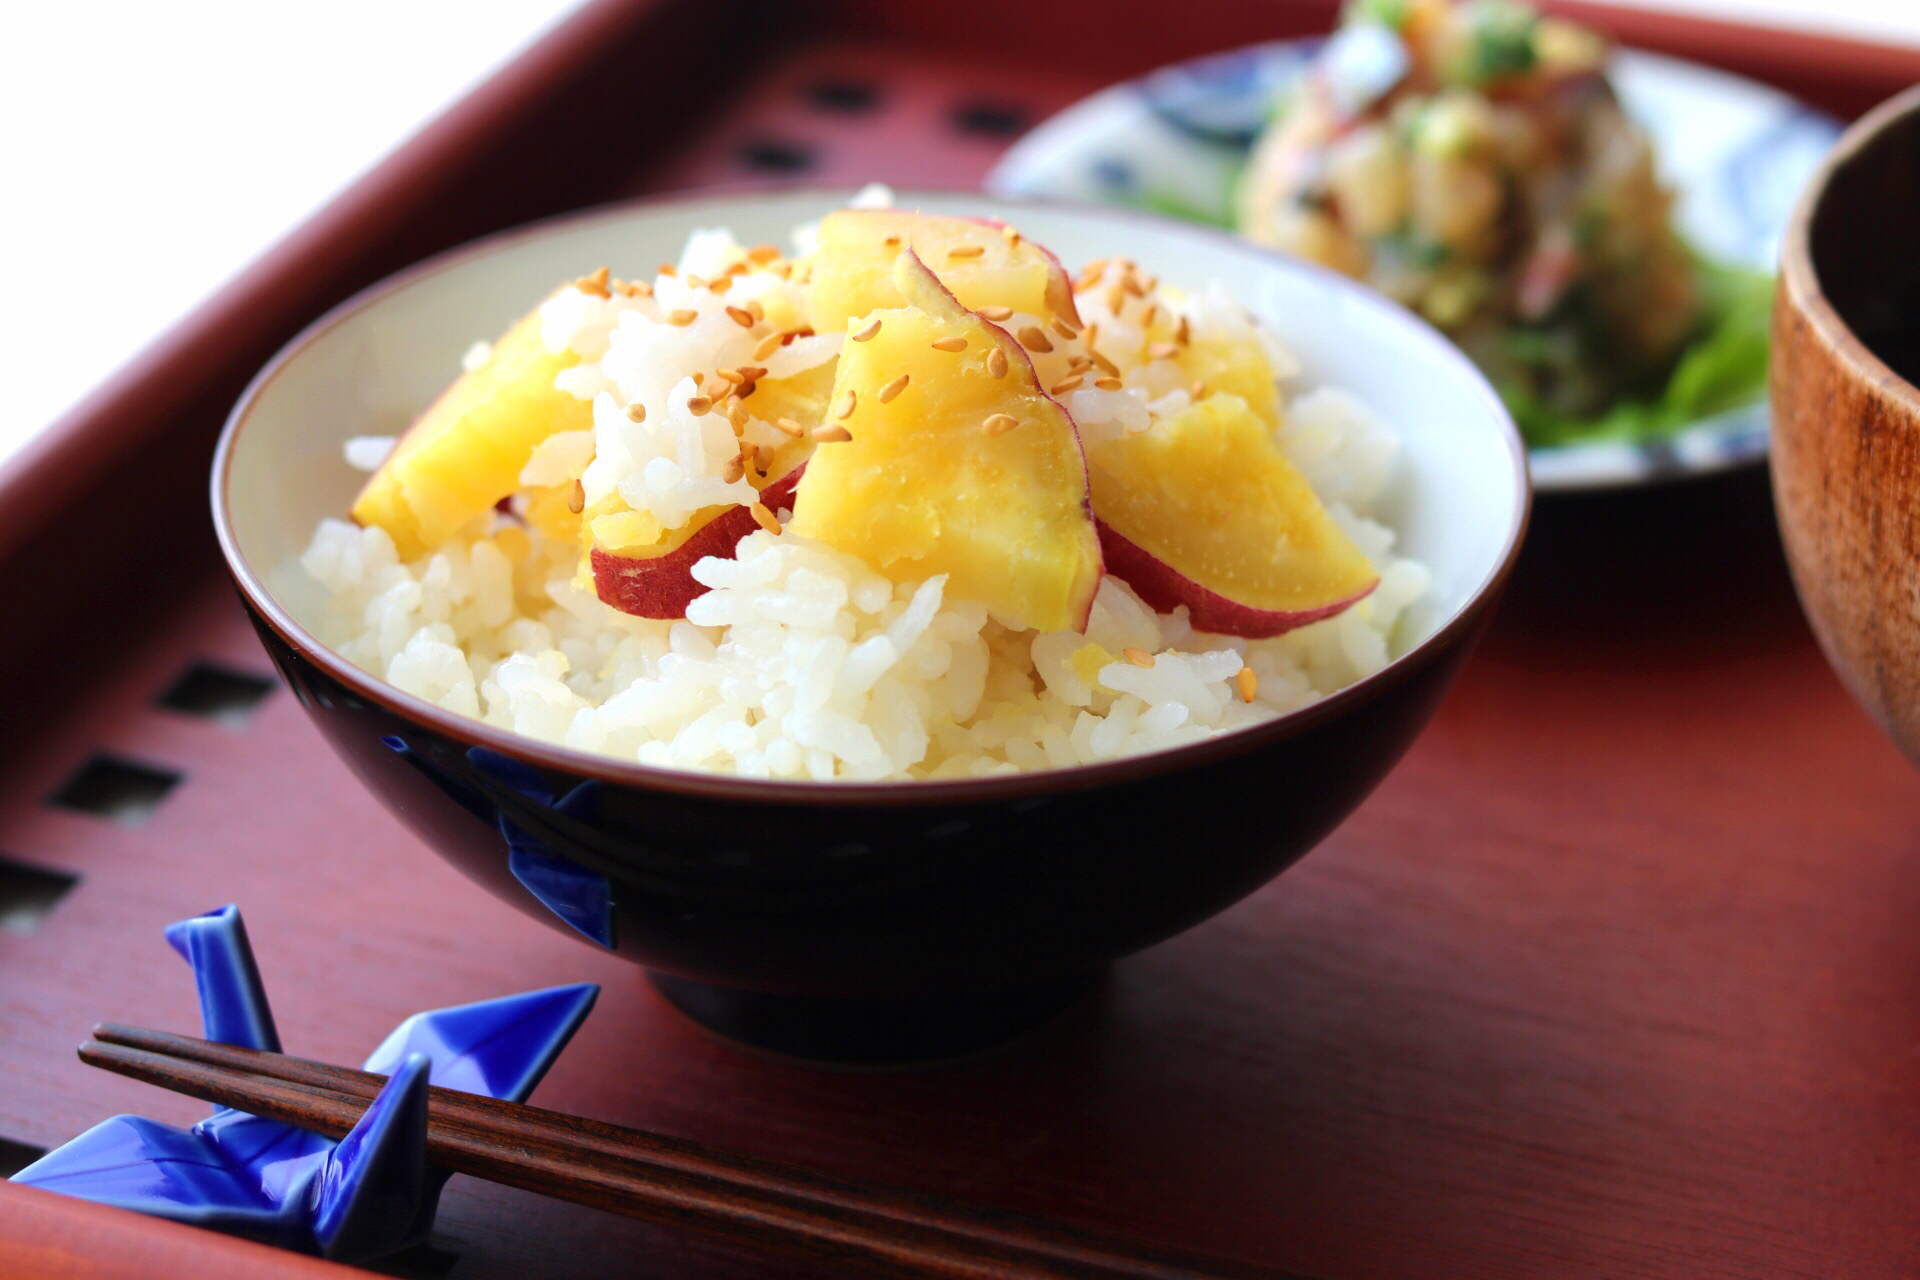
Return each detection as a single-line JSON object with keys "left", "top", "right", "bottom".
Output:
{"left": 1770, "top": 86, "right": 1920, "bottom": 764}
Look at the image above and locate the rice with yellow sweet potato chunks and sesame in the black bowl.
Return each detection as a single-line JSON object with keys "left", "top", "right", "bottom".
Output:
{"left": 301, "top": 193, "right": 1428, "bottom": 779}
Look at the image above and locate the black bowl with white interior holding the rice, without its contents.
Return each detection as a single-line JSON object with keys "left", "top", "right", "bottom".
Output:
{"left": 213, "top": 192, "right": 1528, "bottom": 1061}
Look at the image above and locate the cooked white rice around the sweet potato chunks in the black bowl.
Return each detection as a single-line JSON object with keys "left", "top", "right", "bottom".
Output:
{"left": 300, "top": 213, "right": 1428, "bottom": 779}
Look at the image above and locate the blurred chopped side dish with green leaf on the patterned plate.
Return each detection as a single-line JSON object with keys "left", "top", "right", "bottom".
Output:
{"left": 1238, "top": 0, "right": 1770, "bottom": 445}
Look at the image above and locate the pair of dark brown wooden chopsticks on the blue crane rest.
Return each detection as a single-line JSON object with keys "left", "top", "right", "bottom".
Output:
{"left": 81, "top": 1023, "right": 1284, "bottom": 1280}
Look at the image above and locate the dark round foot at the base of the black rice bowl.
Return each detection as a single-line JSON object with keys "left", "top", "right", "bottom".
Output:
{"left": 647, "top": 969, "right": 1102, "bottom": 1067}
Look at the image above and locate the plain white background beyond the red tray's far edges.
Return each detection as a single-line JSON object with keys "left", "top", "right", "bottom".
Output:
{"left": 0, "top": 0, "right": 1920, "bottom": 468}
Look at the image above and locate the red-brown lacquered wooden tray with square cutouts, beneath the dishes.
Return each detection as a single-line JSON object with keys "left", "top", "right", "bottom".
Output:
{"left": 0, "top": 0, "right": 1920, "bottom": 1280}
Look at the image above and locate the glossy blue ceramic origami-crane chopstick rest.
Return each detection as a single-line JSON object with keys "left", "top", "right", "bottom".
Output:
{"left": 13, "top": 906, "right": 599, "bottom": 1263}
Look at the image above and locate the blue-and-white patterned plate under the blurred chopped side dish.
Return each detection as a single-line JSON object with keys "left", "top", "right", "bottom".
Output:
{"left": 987, "top": 40, "right": 1839, "bottom": 489}
